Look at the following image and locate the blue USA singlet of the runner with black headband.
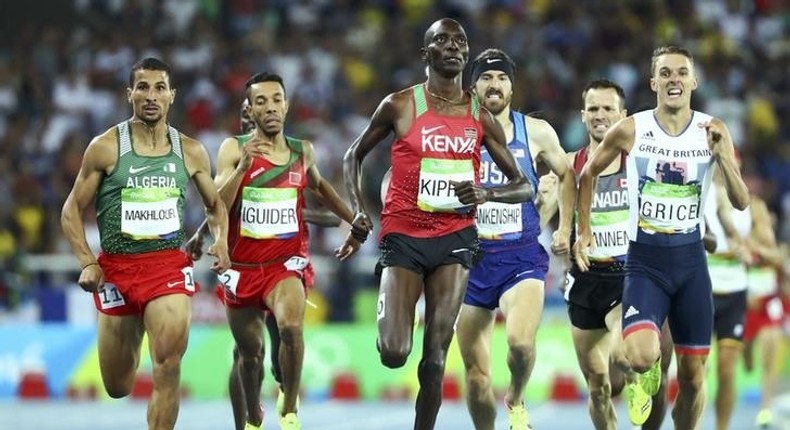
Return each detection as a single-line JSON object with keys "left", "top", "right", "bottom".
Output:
{"left": 476, "top": 111, "right": 540, "bottom": 252}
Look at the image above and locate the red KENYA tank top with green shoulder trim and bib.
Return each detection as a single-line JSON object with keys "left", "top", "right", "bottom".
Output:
{"left": 380, "top": 84, "right": 483, "bottom": 238}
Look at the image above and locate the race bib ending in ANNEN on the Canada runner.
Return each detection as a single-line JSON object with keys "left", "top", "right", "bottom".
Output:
{"left": 588, "top": 209, "right": 628, "bottom": 261}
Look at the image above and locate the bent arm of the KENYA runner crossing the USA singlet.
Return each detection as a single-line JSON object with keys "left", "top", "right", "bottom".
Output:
{"left": 470, "top": 107, "right": 535, "bottom": 204}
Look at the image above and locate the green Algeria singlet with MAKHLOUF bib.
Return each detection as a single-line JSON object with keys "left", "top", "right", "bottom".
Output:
{"left": 96, "top": 121, "right": 189, "bottom": 254}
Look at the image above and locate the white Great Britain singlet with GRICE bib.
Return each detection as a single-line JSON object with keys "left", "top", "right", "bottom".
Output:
{"left": 626, "top": 111, "right": 713, "bottom": 247}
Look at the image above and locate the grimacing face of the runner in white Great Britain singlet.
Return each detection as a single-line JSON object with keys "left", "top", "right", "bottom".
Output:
{"left": 650, "top": 54, "right": 697, "bottom": 109}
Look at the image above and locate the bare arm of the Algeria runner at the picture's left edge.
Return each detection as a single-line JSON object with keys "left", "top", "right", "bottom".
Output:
{"left": 60, "top": 131, "right": 113, "bottom": 292}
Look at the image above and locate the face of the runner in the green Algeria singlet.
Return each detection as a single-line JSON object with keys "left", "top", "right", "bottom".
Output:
{"left": 126, "top": 69, "right": 176, "bottom": 124}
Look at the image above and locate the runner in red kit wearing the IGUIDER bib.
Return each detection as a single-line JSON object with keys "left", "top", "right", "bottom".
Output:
{"left": 190, "top": 73, "right": 359, "bottom": 430}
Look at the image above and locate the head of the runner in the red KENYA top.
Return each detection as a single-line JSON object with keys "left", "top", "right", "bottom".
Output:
{"left": 420, "top": 19, "right": 469, "bottom": 78}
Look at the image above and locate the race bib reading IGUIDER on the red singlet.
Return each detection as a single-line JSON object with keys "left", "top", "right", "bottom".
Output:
{"left": 241, "top": 187, "right": 299, "bottom": 239}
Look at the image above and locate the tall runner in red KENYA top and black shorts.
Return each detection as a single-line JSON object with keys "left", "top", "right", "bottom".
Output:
{"left": 343, "top": 18, "right": 533, "bottom": 430}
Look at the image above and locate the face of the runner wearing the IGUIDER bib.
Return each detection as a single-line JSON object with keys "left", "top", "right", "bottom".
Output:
{"left": 249, "top": 81, "right": 288, "bottom": 136}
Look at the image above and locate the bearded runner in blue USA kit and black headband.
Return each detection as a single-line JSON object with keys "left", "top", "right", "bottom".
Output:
{"left": 457, "top": 49, "right": 576, "bottom": 430}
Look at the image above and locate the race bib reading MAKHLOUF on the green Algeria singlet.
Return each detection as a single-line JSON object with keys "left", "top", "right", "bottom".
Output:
{"left": 121, "top": 188, "right": 181, "bottom": 240}
